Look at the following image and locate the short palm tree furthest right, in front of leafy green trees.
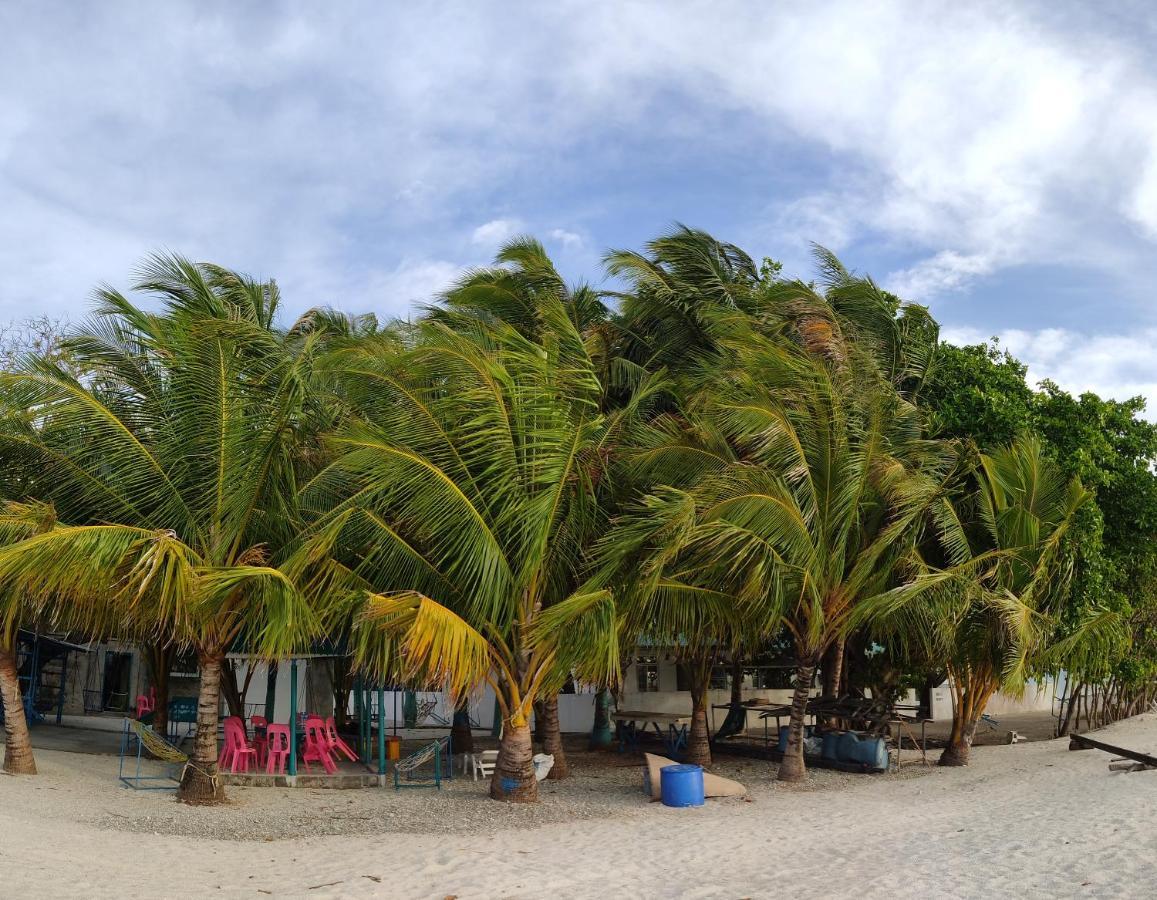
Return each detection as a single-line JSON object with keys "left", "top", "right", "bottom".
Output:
{"left": 871, "top": 435, "right": 1096, "bottom": 766}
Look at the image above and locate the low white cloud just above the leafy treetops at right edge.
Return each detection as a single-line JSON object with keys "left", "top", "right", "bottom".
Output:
{"left": 942, "top": 327, "right": 1157, "bottom": 418}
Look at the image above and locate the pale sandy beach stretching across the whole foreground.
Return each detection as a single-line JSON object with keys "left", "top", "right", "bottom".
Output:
{"left": 0, "top": 715, "right": 1157, "bottom": 900}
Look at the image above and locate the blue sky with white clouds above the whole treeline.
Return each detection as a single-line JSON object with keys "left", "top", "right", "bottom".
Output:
{"left": 0, "top": 0, "right": 1157, "bottom": 407}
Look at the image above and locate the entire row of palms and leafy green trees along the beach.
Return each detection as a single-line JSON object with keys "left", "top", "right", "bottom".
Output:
{"left": 0, "top": 227, "right": 1157, "bottom": 802}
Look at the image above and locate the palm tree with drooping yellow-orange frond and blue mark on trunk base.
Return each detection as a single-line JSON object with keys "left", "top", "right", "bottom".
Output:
{"left": 294, "top": 279, "right": 618, "bottom": 802}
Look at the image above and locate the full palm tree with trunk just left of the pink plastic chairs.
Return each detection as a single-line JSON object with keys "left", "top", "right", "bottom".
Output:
{"left": 0, "top": 257, "right": 316, "bottom": 803}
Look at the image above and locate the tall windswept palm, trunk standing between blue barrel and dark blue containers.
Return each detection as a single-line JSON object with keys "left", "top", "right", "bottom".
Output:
{"left": 609, "top": 227, "right": 956, "bottom": 781}
